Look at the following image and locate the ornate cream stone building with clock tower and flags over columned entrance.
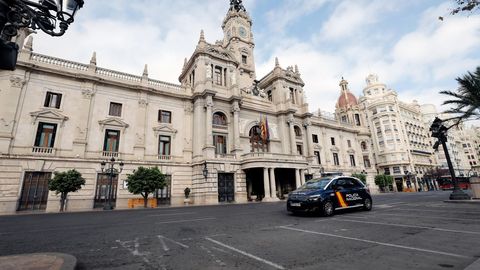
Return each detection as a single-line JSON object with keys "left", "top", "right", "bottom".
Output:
{"left": 0, "top": 1, "right": 376, "bottom": 213}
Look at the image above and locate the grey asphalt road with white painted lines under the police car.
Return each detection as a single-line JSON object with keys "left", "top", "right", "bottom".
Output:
{"left": 0, "top": 192, "right": 480, "bottom": 269}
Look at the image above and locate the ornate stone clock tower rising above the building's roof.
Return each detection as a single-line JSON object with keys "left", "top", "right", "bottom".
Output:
{"left": 222, "top": 0, "right": 255, "bottom": 87}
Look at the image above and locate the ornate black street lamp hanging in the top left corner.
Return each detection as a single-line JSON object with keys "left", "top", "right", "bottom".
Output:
{"left": 0, "top": 0, "right": 84, "bottom": 70}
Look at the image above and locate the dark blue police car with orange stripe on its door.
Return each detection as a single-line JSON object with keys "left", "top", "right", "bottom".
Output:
{"left": 287, "top": 176, "right": 372, "bottom": 216}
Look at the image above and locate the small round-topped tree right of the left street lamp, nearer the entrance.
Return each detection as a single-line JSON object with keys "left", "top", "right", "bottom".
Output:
{"left": 126, "top": 167, "right": 166, "bottom": 208}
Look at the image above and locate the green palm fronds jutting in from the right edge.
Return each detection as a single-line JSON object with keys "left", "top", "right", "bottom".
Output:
{"left": 440, "top": 66, "right": 480, "bottom": 124}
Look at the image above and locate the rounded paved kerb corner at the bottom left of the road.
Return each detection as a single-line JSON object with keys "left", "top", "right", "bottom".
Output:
{"left": 0, "top": 253, "right": 77, "bottom": 270}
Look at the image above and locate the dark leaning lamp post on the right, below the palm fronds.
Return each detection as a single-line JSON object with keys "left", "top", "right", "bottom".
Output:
{"left": 430, "top": 117, "right": 470, "bottom": 200}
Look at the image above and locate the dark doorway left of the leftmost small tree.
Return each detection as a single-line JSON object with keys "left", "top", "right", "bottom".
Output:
{"left": 18, "top": 172, "right": 52, "bottom": 211}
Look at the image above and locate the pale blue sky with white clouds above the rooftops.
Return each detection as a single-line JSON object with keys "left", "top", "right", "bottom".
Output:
{"left": 34, "top": 0, "right": 480, "bottom": 112}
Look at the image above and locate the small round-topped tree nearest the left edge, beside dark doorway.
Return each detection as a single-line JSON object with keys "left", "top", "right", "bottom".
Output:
{"left": 48, "top": 169, "right": 85, "bottom": 212}
